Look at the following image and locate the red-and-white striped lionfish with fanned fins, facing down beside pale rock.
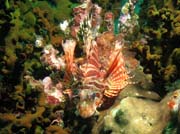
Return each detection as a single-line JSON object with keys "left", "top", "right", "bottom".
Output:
{"left": 77, "top": 40, "right": 133, "bottom": 118}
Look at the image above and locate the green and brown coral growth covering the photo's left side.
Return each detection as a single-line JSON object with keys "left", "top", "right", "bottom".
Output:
{"left": 0, "top": 0, "right": 73, "bottom": 133}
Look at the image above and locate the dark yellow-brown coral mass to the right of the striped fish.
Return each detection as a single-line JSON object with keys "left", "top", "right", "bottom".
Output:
{"left": 133, "top": 0, "right": 180, "bottom": 95}
